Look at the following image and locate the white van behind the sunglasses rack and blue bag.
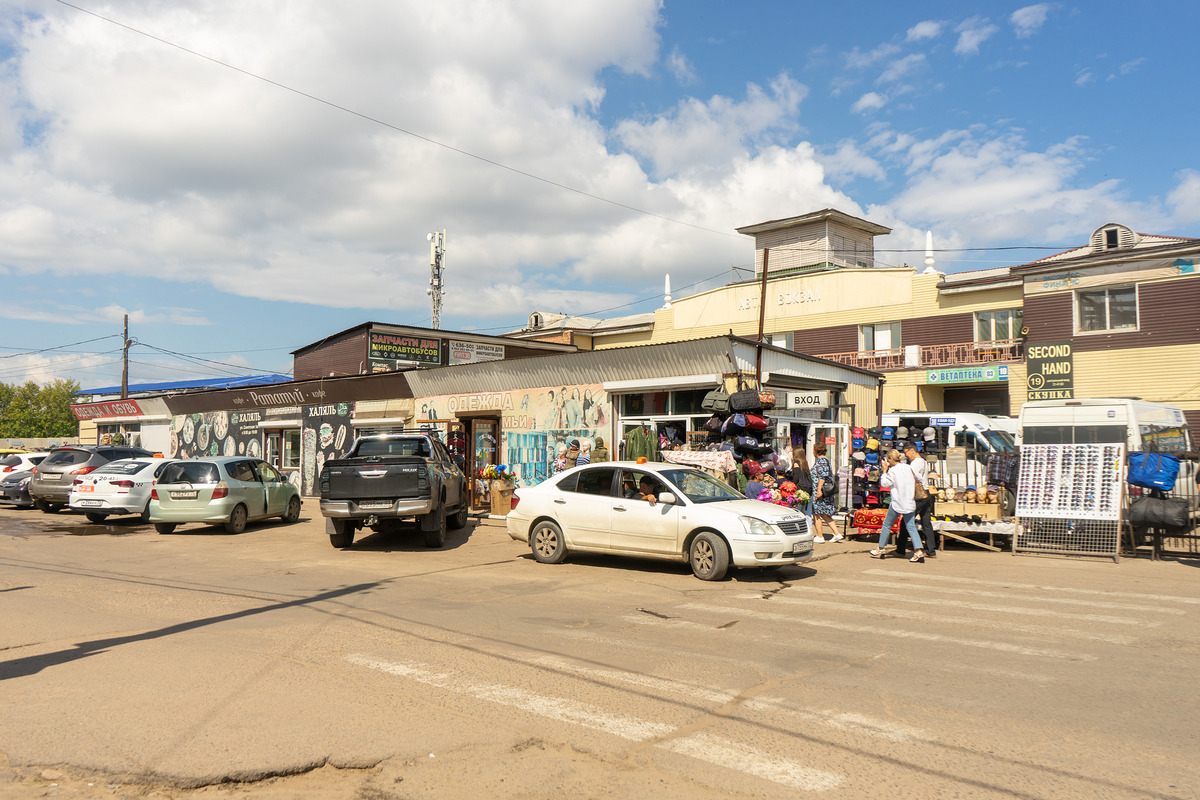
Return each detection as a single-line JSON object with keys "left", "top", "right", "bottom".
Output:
{"left": 1021, "top": 397, "right": 1192, "bottom": 453}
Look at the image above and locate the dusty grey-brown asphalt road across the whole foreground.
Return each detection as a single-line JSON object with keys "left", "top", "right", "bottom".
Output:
{"left": 0, "top": 501, "right": 1200, "bottom": 799}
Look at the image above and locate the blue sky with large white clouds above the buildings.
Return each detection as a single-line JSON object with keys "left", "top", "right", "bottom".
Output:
{"left": 0, "top": 0, "right": 1200, "bottom": 389}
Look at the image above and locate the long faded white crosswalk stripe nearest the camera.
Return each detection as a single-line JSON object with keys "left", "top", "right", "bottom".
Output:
{"left": 346, "top": 654, "right": 845, "bottom": 792}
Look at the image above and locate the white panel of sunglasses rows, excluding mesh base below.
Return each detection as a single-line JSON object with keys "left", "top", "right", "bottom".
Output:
{"left": 1016, "top": 445, "right": 1124, "bottom": 522}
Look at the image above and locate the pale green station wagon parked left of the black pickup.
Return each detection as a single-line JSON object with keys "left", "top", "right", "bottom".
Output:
{"left": 150, "top": 456, "right": 300, "bottom": 534}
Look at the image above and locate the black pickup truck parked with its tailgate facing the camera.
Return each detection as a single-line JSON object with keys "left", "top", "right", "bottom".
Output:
{"left": 320, "top": 433, "right": 470, "bottom": 548}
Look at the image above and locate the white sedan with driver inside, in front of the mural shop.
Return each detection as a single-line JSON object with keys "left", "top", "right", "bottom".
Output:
{"left": 506, "top": 462, "right": 812, "bottom": 581}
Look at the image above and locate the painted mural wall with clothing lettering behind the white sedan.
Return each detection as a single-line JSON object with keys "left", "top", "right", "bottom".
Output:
{"left": 418, "top": 384, "right": 612, "bottom": 486}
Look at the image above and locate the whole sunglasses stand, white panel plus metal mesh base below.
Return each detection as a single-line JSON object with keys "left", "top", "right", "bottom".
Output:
{"left": 1013, "top": 444, "right": 1124, "bottom": 561}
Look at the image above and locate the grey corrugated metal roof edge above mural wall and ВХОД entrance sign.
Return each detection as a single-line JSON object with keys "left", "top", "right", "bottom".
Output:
{"left": 406, "top": 336, "right": 878, "bottom": 397}
